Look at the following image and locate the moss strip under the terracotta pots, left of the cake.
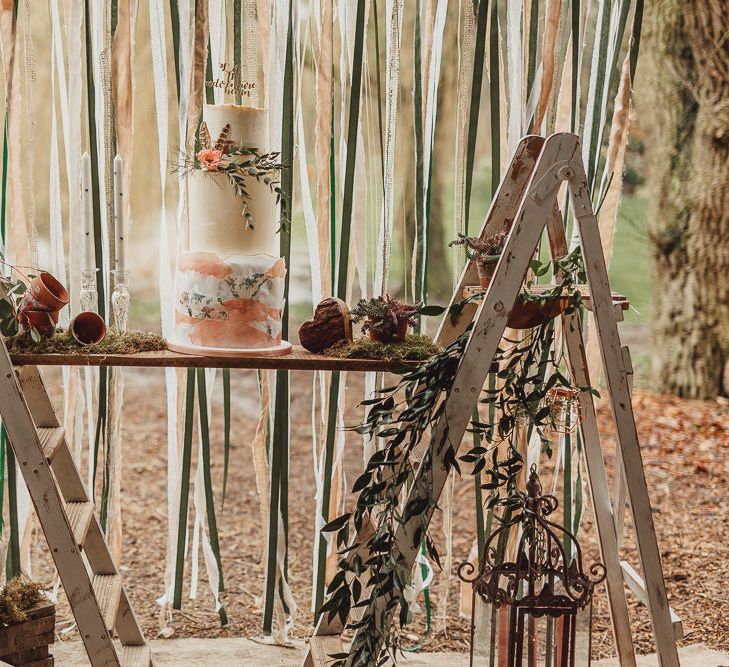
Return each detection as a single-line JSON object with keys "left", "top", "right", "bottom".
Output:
{"left": 5, "top": 329, "right": 167, "bottom": 354}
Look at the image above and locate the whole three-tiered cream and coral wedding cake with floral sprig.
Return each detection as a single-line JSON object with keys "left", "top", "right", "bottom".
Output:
{"left": 169, "top": 104, "right": 291, "bottom": 356}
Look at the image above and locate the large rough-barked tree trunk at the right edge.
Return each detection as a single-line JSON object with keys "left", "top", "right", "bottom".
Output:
{"left": 640, "top": 0, "right": 729, "bottom": 398}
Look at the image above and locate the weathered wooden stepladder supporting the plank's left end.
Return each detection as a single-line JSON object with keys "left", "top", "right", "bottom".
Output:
{"left": 0, "top": 342, "right": 153, "bottom": 667}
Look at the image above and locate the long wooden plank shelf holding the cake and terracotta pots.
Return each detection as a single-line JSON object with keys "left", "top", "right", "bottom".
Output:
{"left": 10, "top": 345, "right": 416, "bottom": 373}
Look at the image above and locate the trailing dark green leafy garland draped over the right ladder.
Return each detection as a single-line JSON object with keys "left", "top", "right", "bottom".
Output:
{"left": 319, "top": 249, "right": 596, "bottom": 667}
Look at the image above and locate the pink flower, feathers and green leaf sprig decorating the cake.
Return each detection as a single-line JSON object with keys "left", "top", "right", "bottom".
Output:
{"left": 180, "top": 121, "right": 285, "bottom": 229}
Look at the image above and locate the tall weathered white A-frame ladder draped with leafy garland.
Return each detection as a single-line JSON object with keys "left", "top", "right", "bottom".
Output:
{"left": 304, "top": 134, "right": 682, "bottom": 667}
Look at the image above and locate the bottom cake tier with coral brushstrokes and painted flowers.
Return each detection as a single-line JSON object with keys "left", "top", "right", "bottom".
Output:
{"left": 172, "top": 251, "right": 286, "bottom": 350}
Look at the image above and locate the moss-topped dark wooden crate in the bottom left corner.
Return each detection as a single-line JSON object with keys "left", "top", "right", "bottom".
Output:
{"left": 0, "top": 600, "right": 56, "bottom": 667}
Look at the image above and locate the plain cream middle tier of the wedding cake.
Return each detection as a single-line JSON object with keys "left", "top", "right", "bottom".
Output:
{"left": 187, "top": 169, "right": 279, "bottom": 257}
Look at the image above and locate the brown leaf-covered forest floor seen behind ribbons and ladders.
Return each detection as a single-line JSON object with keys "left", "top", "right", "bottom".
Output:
{"left": 33, "top": 369, "right": 729, "bottom": 657}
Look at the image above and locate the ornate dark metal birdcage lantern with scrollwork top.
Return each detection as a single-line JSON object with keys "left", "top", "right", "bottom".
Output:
{"left": 458, "top": 466, "right": 605, "bottom": 667}
